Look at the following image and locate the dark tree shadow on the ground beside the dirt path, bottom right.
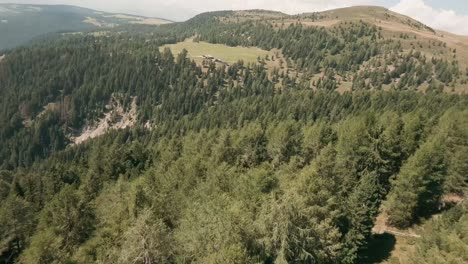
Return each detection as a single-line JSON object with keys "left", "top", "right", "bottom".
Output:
{"left": 361, "top": 233, "right": 396, "bottom": 263}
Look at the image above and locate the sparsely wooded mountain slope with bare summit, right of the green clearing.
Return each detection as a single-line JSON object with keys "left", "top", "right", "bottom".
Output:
{"left": 188, "top": 6, "right": 468, "bottom": 93}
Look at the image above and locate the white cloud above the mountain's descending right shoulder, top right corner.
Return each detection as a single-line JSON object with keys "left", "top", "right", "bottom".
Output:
{"left": 390, "top": 0, "right": 468, "bottom": 35}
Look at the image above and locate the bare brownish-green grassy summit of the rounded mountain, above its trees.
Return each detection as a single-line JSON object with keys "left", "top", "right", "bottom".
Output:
{"left": 217, "top": 6, "right": 468, "bottom": 67}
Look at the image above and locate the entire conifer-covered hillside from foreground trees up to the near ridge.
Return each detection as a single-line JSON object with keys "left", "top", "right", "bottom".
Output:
{"left": 0, "top": 5, "right": 468, "bottom": 263}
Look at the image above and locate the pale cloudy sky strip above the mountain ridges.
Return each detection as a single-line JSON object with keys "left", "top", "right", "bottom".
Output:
{"left": 0, "top": 0, "right": 468, "bottom": 35}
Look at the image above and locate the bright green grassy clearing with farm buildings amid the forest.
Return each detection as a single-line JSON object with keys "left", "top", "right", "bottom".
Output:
{"left": 161, "top": 39, "right": 273, "bottom": 64}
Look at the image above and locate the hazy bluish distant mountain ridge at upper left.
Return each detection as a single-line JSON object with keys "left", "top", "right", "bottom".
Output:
{"left": 0, "top": 4, "right": 170, "bottom": 50}
